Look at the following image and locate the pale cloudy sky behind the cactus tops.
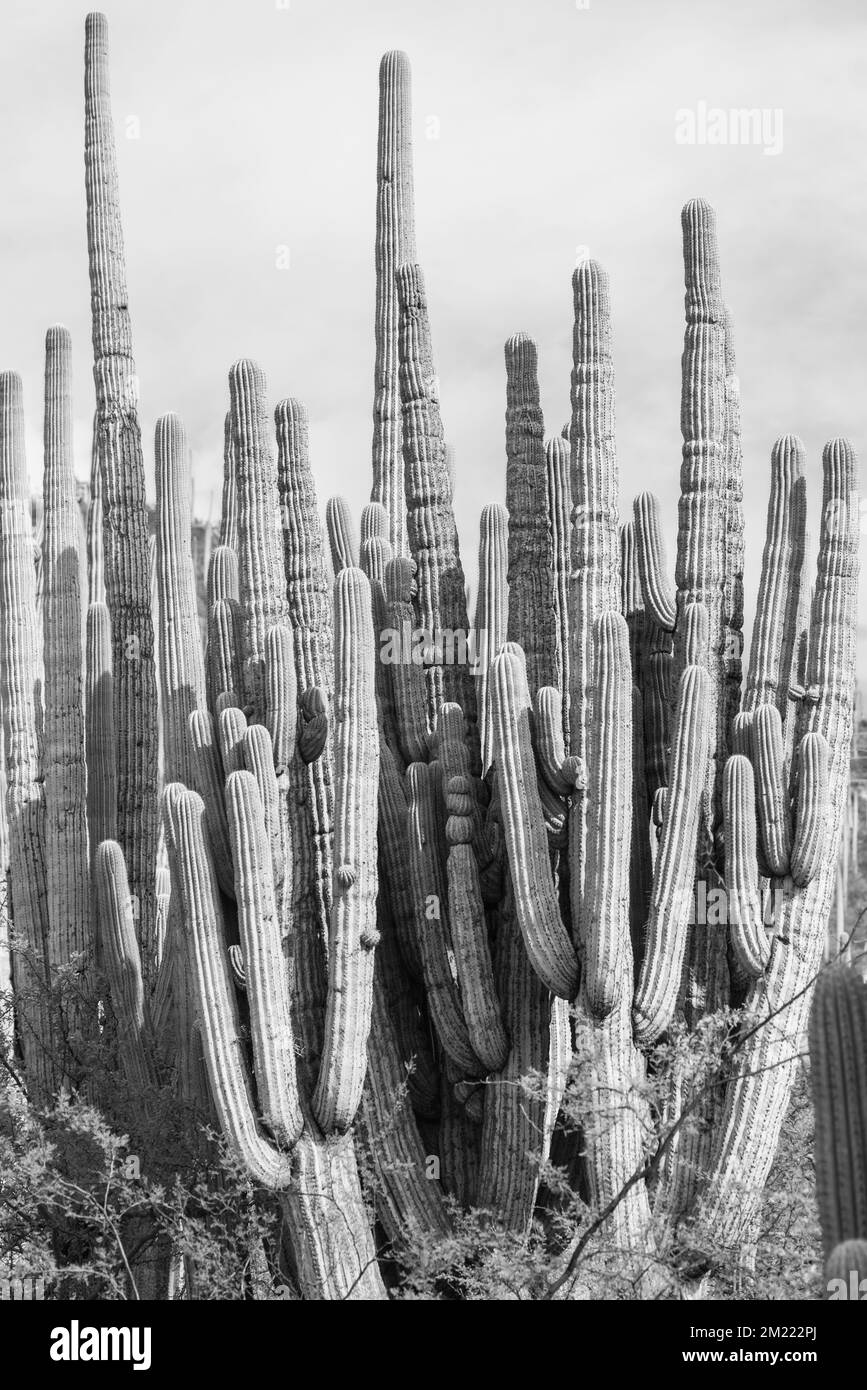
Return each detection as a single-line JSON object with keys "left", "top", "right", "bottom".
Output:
{"left": 0, "top": 0, "right": 867, "bottom": 680}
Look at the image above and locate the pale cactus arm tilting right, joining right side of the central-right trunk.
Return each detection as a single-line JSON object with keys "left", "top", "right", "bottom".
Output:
{"left": 632, "top": 666, "right": 710, "bottom": 1045}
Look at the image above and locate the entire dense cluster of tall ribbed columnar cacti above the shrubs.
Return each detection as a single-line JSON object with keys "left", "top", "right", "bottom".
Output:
{"left": 0, "top": 14, "right": 867, "bottom": 1298}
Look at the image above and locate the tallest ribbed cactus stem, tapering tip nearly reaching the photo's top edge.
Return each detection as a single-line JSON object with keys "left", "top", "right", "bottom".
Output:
{"left": 85, "top": 14, "right": 158, "bottom": 979}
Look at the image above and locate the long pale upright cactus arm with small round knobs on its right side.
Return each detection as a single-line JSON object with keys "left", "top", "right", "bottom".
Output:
{"left": 311, "top": 569, "right": 379, "bottom": 1133}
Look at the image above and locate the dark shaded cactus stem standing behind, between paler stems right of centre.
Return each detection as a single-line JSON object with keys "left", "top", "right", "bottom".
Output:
{"left": 506, "top": 334, "right": 557, "bottom": 701}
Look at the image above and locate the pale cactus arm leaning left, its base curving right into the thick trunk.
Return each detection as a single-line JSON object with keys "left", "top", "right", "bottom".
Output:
{"left": 492, "top": 651, "right": 578, "bottom": 999}
